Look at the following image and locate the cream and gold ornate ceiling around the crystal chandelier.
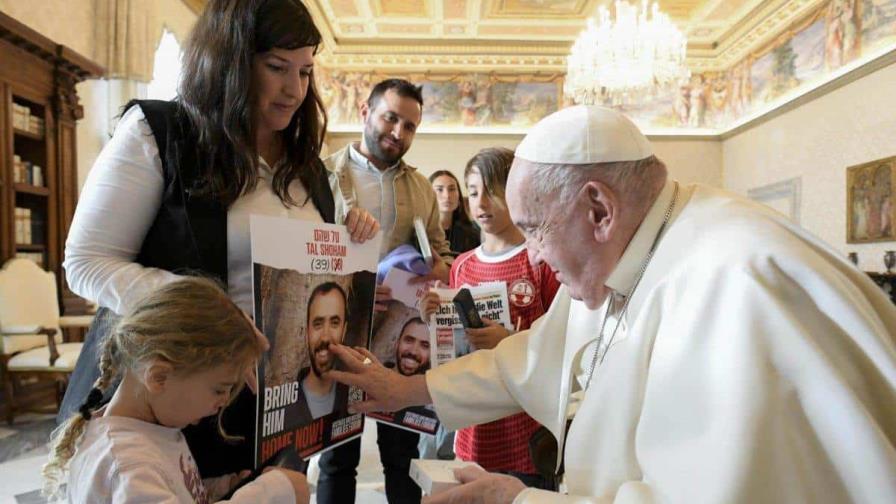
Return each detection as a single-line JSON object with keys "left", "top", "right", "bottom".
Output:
{"left": 185, "top": 0, "right": 828, "bottom": 74}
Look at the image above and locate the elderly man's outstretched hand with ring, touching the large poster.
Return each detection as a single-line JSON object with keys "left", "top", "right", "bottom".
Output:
{"left": 325, "top": 345, "right": 432, "bottom": 413}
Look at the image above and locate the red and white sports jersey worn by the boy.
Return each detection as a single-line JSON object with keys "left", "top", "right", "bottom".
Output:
{"left": 451, "top": 244, "right": 560, "bottom": 474}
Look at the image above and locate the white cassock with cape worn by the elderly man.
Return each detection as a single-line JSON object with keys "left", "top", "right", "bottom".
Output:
{"left": 426, "top": 182, "right": 896, "bottom": 503}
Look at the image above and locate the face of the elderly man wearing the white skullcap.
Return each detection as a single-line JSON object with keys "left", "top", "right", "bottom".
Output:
{"left": 506, "top": 158, "right": 615, "bottom": 310}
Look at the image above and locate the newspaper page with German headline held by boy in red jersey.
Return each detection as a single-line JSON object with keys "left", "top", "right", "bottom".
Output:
{"left": 429, "top": 282, "right": 515, "bottom": 367}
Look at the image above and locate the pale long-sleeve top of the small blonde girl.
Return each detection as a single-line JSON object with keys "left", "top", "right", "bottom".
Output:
{"left": 66, "top": 416, "right": 295, "bottom": 504}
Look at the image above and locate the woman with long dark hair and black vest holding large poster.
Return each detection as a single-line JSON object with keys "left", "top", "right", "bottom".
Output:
{"left": 60, "top": 0, "right": 379, "bottom": 484}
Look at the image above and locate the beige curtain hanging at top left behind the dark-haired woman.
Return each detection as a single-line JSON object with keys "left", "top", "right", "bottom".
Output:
{"left": 94, "top": 0, "right": 161, "bottom": 82}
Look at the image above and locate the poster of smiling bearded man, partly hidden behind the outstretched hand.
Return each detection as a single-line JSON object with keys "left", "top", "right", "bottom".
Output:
{"left": 367, "top": 268, "right": 439, "bottom": 434}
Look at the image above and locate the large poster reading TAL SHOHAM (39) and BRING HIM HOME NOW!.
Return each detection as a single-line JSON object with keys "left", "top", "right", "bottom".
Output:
{"left": 250, "top": 215, "right": 381, "bottom": 466}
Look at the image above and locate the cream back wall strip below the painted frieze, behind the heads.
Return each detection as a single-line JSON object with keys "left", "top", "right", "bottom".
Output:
{"left": 327, "top": 133, "right": 722, "bottom": 186}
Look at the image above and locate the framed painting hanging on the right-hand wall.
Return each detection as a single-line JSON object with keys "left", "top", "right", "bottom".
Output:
{"left": 846, "top": 156, "right": 896, "bottom": 243}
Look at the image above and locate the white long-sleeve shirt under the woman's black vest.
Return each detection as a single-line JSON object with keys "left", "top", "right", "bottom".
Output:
{"left": 63, "top": 106, "right": 326, "bottom": 314}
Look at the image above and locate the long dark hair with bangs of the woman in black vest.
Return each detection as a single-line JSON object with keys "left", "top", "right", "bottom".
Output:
{"left": 179, "top": 0, "right": 327, "bottom": 206}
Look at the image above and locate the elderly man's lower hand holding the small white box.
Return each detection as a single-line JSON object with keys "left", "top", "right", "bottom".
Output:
{"left": 423, "top": 466, "right": 526, "bottom": 504}
